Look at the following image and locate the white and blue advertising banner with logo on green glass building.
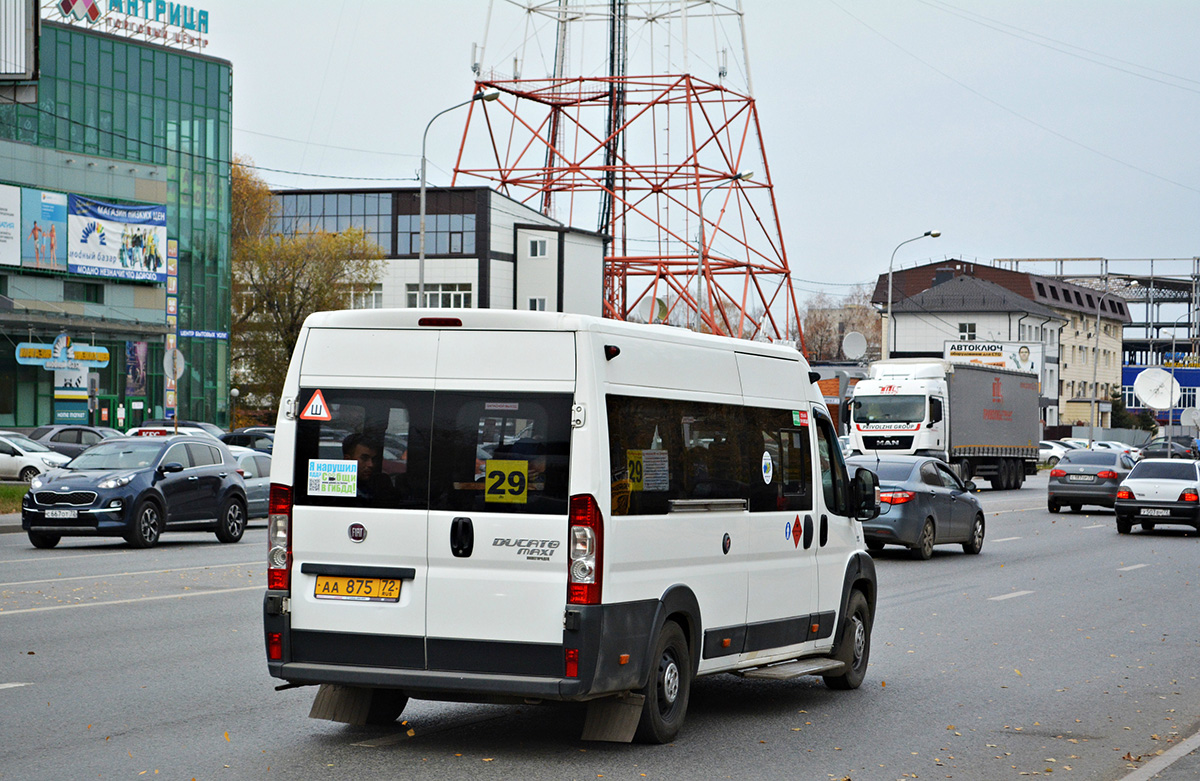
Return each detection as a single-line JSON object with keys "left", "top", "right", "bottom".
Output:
{"left": 67, "top": 196, "right": 167, "bottom": 282}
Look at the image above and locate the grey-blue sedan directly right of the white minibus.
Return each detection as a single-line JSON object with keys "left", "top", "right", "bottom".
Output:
{"left": 846, "top": 456, "right": 984, "bottom": 559}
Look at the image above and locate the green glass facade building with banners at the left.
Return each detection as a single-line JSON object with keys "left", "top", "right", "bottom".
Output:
{"left": 0, "top": 19, "right": 232, "bottom": 427}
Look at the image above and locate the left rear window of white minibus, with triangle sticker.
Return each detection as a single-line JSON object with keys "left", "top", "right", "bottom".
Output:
{"left": 293, "top": 389, "right": 433, "bottom": 509}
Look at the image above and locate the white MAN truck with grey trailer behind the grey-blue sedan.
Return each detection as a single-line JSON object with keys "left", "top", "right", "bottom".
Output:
{"left": 850, "top": 359, "right": 1042, "bottom": 488}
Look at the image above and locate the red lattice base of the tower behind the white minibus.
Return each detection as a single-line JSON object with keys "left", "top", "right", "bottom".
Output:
{"left": 454, "top": 76, "right": 803, "bottom": 350}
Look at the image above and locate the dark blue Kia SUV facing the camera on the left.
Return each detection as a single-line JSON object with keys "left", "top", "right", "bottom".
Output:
{"left": 20, "top": 435, "right": 246, "bottom": 548}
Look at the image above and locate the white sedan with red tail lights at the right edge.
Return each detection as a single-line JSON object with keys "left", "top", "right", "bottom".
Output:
{"left": 1116, "top": 458, "right": 1200, "bottom": 534}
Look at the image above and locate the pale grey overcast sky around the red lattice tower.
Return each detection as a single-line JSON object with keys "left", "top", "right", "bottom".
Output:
{"left": 200, "top": 0, "right": 1200, "bottom": 302}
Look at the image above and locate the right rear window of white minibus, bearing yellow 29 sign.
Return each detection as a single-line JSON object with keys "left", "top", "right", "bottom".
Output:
{"left": 430, "top": 392, "right": 571, "bottom": 515}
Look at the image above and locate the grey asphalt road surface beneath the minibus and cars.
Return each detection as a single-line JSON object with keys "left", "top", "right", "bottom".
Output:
{"left": 0, "top": 477, "right": 1200, "bottom": 781}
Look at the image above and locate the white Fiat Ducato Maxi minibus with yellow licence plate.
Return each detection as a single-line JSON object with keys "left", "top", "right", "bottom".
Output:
{"left": 264, "top": 310, "right": 878, "bottom": 743}
